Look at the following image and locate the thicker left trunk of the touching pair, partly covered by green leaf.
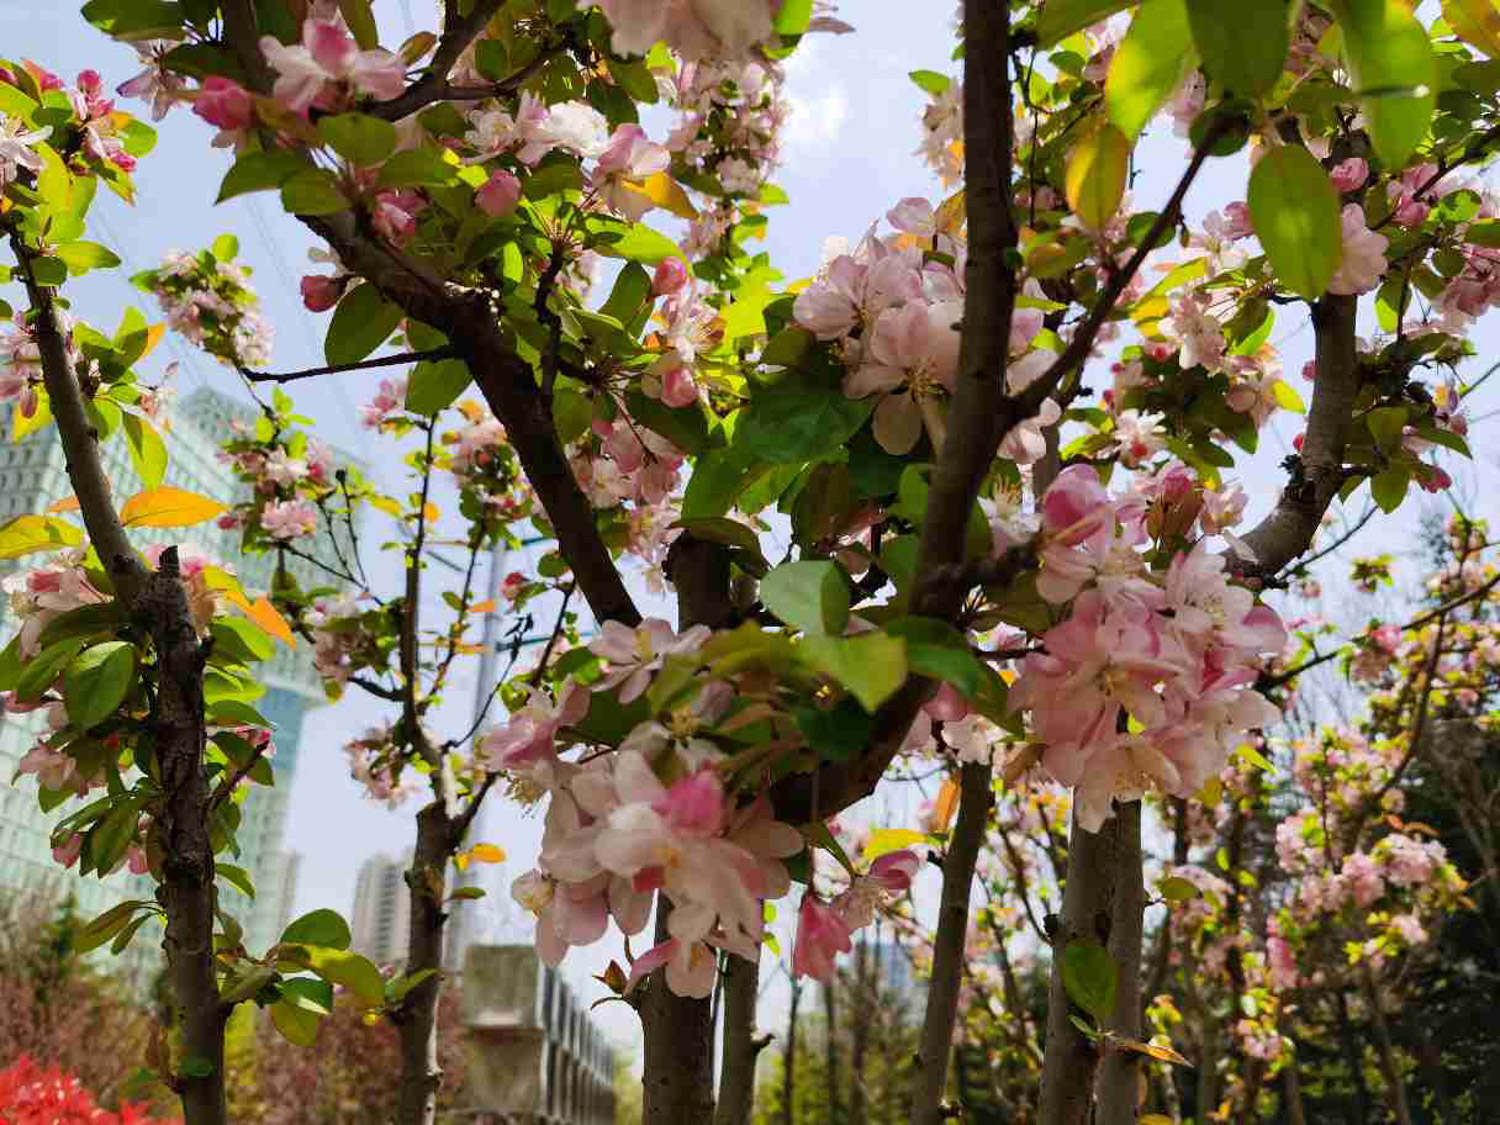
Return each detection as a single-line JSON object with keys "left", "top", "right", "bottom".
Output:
{"left": 1041, "top": 810, "right": 1134, "bottom": 1125}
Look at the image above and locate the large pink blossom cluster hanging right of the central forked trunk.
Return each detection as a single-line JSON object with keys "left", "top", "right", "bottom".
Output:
{"left": 1013, "top": 465, "right": 1286, "bottom": 831}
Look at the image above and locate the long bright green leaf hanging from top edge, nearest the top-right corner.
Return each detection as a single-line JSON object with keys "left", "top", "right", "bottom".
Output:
{"left": 1338, "top": 0, "right": 1437, "bottom": 167}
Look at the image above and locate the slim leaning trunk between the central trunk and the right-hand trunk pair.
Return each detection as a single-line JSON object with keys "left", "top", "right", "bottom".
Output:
{"left": 911, "top": 762, "right": 995, "bottom": 1125}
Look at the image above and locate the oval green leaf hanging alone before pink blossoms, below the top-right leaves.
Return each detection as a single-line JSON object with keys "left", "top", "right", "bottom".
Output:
{"left": 1248, "top": 144, "right": 1344, "bottom": 300}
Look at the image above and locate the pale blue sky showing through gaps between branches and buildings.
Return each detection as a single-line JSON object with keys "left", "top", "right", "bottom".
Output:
{"left": 0, "top": 0, "right": 1500, "bottom": 1041}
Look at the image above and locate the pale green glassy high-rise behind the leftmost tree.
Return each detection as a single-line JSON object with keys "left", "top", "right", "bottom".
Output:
{"left": 0, "top": 390, "right": 343, "bottom": 974}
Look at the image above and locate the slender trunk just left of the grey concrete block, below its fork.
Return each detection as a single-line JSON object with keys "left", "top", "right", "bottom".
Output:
{"left": 395, "top": 804, "right": 453, "bottom": 1125}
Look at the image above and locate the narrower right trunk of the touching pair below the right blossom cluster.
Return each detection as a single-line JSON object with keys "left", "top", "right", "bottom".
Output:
{"left": 1097, "top": 801, "right": 1146, "bottom": 1125}
